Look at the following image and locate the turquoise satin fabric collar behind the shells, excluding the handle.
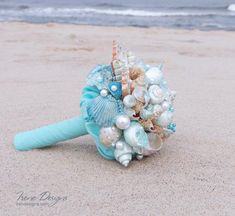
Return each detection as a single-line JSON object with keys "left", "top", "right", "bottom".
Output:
{"left": 80, "top": 86, "right": 115, "bottom": 160}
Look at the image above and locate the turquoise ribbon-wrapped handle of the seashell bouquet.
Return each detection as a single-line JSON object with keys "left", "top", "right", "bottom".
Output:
{"left": 14, "top": 116, "right": 88, "bottom": 151}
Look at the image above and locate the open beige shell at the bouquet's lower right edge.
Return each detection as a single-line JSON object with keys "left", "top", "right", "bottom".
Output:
{"left": 143, "top": 133, "right": 163, "bottom": 156}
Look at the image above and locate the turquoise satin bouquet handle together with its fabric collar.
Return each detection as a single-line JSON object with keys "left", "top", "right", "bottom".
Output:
{"left": 14, "top": 86, "right": 115, "bottom": 160}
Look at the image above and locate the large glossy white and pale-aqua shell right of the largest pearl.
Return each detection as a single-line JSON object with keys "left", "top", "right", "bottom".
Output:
{"left": 123, "top": 121, "right": 149, "bottom": 150}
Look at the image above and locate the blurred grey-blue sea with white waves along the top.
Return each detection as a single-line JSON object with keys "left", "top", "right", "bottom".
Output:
{"left": 0, "top": 0, "right": 235, "bottom": 30}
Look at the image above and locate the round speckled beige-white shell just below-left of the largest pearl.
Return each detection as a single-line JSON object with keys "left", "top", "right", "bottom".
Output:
{"left": 100, "top": 126, "right": 122, "bottom": 147}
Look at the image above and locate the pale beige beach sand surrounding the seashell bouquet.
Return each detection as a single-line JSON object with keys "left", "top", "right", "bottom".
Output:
{"left": 0, "top": 23, "right": 235, "bottom": 216}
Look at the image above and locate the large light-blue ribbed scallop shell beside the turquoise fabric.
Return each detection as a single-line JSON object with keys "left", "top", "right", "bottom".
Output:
{"left": 87, "top": 95, "right": 123, "bottom": 127}
